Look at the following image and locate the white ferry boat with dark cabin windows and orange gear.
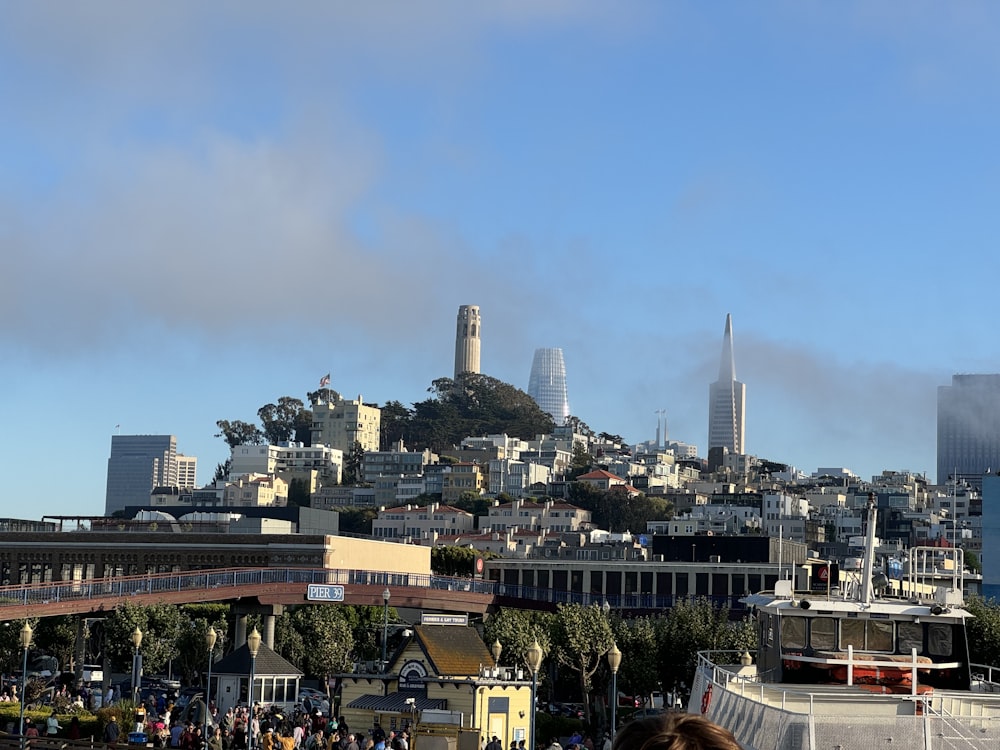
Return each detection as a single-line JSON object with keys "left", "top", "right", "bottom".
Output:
{"left": 688, "top": 496, "right": 1000, "bottom": 750}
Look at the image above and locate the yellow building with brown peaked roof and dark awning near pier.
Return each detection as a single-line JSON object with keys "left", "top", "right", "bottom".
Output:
{"left": 340, "top": 625, "right": 532, "bottom": 748}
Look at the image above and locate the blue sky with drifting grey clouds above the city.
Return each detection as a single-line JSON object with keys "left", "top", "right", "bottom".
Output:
{"left": 0, "top": 0, "right": 1000, "bottom": 518}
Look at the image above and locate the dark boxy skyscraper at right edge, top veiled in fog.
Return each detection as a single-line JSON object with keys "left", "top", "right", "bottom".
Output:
{"left": 937, "top": 375, "right": 1000, "bottom": 487}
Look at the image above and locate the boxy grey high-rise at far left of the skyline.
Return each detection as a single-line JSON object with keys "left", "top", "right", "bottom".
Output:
{"left": 104, "top": 435, "right": 177, "bottom": 516}
